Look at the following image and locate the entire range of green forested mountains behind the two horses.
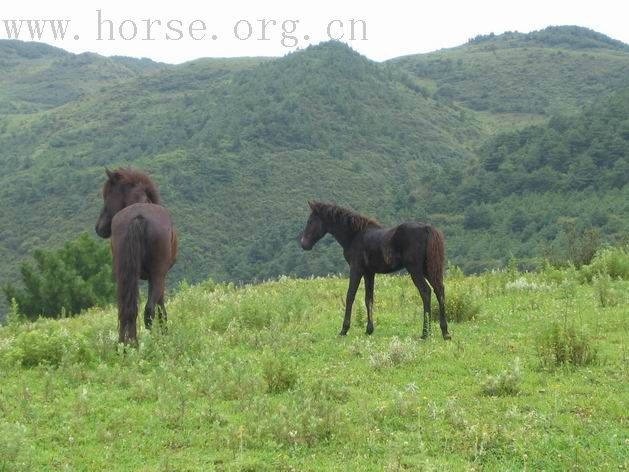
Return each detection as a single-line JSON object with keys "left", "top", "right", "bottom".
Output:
{"left": 0, "top": 27, "right": 629, "bottom": 306}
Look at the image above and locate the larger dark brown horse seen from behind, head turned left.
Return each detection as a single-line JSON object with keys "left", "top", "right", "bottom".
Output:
{"left": 96, "top": 169, "right": 177, "bottom": 344}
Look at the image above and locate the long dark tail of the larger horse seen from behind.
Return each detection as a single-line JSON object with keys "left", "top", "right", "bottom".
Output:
{"left": 116, "top": 215, "right": 146, "bottom": 343}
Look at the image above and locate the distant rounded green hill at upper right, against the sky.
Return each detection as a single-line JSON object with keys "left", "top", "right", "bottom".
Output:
{"left": 392, "top": 27, "right": 629, "bottom": 121}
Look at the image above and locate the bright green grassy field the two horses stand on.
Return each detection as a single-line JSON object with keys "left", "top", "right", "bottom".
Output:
{"left": 0, "top": 269, "right": 629, "bottom": 471}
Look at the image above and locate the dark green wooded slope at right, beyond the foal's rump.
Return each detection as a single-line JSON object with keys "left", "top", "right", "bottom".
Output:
{"left": 430, "top": 88, "right": 629, "bottom": 270}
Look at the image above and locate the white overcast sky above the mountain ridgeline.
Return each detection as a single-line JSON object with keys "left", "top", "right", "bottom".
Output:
{"left": 0, "top": 0, "right": 629, "bottom": 63}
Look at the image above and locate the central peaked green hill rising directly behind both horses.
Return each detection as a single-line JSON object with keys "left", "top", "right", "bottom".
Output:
{"left": 0, "top": 43, "right": 478, "bottom": 292}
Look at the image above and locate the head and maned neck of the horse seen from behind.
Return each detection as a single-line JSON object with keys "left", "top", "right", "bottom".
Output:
{"left": 95, "top": 169, "right": 159, "bottom": 239}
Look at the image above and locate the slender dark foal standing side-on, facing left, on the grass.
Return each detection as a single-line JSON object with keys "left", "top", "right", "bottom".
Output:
{"left": 301, "top": 202, "right": 450, "bottom": 339}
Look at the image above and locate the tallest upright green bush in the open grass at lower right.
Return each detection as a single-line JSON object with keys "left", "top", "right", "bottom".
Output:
{"left": 537, "top": 323, "right": 597, "bottom": 368}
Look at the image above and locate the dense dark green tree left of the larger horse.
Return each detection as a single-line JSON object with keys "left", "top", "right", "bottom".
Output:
{"left": 2, "top": 233, "right": 115, "bottom": 319}
